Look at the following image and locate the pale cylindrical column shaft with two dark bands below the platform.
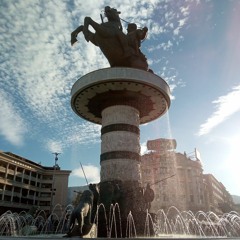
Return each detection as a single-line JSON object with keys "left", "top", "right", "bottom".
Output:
{"left": 100, "top": 105, "right": 141, "bottom": 182}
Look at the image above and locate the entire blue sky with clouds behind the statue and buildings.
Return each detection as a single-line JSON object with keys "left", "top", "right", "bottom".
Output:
{"left": 0, "top": 0, "right": 240, "bottom": 195}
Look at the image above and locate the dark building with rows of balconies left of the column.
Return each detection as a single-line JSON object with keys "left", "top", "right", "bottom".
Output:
{"left": 0, "top": 152, "right": 71, "bottom": 214}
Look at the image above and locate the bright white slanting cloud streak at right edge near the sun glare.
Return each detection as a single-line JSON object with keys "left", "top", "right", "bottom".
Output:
{"left": 197, "top": 85, "right": 240, "bottom": 136}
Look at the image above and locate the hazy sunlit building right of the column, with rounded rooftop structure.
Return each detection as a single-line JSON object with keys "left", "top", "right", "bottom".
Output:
{"left": 141, "top": 139, "right": 233, "bottom": 213}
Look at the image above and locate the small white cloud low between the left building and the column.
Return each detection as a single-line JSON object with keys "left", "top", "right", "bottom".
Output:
{"left": 71, "top": 165, "right": 100, "bottom": 183}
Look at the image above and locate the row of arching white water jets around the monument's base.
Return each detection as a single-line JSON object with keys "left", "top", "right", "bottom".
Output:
{"left": 0, "top": 204, "right": 240, "bottom": 239}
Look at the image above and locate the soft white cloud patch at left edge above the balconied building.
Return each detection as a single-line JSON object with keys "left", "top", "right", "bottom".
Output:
{"left": 0, "top": 90, "right": 26, "bottom": 146}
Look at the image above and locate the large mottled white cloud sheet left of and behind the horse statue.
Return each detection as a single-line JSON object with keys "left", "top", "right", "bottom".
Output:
{"left": 0, "top": 0, "right": 189, "bottom": 151}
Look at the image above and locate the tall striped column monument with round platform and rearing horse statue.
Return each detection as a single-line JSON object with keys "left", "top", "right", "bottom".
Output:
{"left": 71, "top": 6, "right": 170, "bottom": 237}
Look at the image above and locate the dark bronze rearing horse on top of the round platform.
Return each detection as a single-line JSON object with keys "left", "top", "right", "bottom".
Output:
{"left": 71, "top": 6, "right": 149, "bottom": 71}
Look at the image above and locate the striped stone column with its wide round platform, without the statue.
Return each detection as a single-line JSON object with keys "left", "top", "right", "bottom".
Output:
{"left": 71, "top": 67, "right": 170, "bottom": 237}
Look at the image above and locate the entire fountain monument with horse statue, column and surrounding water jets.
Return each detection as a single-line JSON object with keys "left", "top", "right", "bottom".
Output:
{"left": 0, "top": 6, "right": 240, "bottom": 239}
